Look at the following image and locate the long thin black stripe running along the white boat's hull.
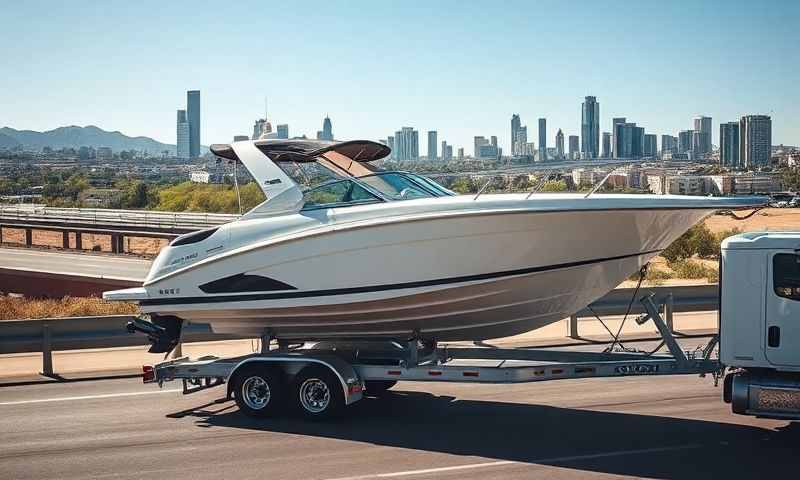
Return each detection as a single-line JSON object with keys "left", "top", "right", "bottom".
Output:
{"left": 139, "top": 249, "right": 661, "bottom": 306}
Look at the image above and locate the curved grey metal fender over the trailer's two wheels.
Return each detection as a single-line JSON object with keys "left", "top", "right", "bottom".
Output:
{"left": 225, "top": 354, "right": 364, "bottom": 405}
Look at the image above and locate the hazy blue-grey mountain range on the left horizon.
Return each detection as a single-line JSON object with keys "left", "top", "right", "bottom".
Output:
{"left": 0, "top": 125, "right": 175, "bottom": 155}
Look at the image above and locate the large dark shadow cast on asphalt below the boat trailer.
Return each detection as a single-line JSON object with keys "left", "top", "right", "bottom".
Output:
{"left": 169, "top": 391, "right": 800, "bottom": 479}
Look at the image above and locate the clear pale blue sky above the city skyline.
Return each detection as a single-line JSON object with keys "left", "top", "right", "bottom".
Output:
{"left": 0, "top": 0, "right": 800, "bottom": 152}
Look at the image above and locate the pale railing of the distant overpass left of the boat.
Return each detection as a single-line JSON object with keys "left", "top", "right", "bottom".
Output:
{"left": 0, "top": 205, "right": 239, "bottom": 230}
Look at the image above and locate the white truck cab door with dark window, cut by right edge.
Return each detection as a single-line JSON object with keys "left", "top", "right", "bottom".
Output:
{"left": 766, "top": 250, "right": 800, "bottom": 366}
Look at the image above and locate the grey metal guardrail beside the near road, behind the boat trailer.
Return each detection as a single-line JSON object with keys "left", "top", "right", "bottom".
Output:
{"left": 0, "top": 284, "right": 719, "bottom": 376}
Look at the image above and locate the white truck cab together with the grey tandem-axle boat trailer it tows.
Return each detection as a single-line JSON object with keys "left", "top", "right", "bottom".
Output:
{"left": 138, "top": 233, "right": 800, "bottom": 419}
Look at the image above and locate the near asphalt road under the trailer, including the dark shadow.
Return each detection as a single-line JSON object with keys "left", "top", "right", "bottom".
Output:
{"left": 0, "top": 340, "right": 800, "bottom": 480}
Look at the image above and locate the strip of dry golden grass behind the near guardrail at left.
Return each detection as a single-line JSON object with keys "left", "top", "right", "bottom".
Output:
{"left": 0, "top": 296, "right": 139, "bottom": 320}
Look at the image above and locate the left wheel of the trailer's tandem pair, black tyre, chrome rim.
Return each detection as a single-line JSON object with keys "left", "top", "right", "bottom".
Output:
{"left": 233, "top": 365, "right": 286, "bottom": 418}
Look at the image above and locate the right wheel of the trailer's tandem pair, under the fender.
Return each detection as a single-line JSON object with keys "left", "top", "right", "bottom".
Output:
{"left": 292, "top": 365, "right": 344, "bottom": 420}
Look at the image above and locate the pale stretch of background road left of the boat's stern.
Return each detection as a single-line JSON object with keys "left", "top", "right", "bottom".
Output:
{"left": 0, "top": 248, "right": 150, "bottom": 281}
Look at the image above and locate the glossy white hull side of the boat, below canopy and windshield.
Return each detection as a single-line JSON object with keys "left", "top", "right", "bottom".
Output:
{"left": 141, "top": 209, "right": 713, "bottom": 341}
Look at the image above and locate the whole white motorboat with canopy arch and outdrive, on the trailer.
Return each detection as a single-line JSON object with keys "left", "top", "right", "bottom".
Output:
{"left": 104, "top": 140, "right": 764, "bottom": 351}
